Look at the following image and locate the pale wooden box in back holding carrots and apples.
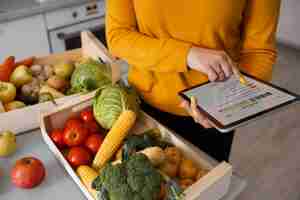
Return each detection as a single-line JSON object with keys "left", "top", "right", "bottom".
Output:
{"left": 0, "top": 31, "right": 120, "bottom": 134}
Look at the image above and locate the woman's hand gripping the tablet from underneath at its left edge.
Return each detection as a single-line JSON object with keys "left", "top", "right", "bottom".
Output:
{"left": 180, "top": 97, "right": 213, "bottom": 128}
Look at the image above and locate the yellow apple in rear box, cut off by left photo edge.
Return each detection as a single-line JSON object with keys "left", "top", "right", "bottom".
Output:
{"left": 0, "top": 81, "right": 17, "bottom": 104}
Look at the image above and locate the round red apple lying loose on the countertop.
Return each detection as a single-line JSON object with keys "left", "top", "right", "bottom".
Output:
{"left": 10, "top": 157, "right": 46, "bottom": 189}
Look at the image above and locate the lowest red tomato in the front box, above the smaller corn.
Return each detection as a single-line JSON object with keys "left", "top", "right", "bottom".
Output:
{"left": 67, "top": 147, "right": 92, "bottom": 167}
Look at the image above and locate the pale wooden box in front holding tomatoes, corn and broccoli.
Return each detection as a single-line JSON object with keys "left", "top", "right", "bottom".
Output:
{"left": 40, "top": 94, "right": 232, "bottom": 200}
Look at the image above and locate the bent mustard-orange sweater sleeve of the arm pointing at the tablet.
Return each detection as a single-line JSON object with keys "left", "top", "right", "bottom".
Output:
{"left": 106, "top": 0, "right": 191, "bottom": 72}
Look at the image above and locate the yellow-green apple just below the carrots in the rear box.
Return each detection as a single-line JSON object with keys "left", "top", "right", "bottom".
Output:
{"left": 9, "top": 65, "right": 32, "bottom": 88}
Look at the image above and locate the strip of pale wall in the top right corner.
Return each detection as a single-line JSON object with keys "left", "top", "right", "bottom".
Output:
{"left": 278, "top": 0, "right": 300, "bottom": 48}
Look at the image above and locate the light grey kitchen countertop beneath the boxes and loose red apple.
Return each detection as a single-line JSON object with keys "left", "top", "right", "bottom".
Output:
{"left": 0, "top": 130, "right": 246, "bottom": 200}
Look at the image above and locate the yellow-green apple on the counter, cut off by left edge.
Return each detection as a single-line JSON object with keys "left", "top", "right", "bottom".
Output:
{"left": 0, "top": 131, "right": 17, "bottom": 157}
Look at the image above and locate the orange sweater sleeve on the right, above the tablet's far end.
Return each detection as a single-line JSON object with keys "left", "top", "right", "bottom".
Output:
{"left": 240, "top": 0, "right": 280, "bottom": 81}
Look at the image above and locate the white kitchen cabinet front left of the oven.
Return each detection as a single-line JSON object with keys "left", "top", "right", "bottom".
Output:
{"left": 0, "top": 15, "right": 50, "bottom": 62}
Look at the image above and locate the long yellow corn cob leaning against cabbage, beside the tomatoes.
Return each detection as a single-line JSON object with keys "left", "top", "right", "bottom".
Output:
{"left": 93, "top": 110, "right": 136, "bottom": 170}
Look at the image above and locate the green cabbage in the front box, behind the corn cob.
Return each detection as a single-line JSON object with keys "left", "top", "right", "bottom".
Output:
{"left": 93, "top": 85, "right": 139, "bottom": 129}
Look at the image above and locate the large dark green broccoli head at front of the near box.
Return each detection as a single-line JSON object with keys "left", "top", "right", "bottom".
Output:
{"left": 92, "top": 154, "right": 164, "bottom": 200}
